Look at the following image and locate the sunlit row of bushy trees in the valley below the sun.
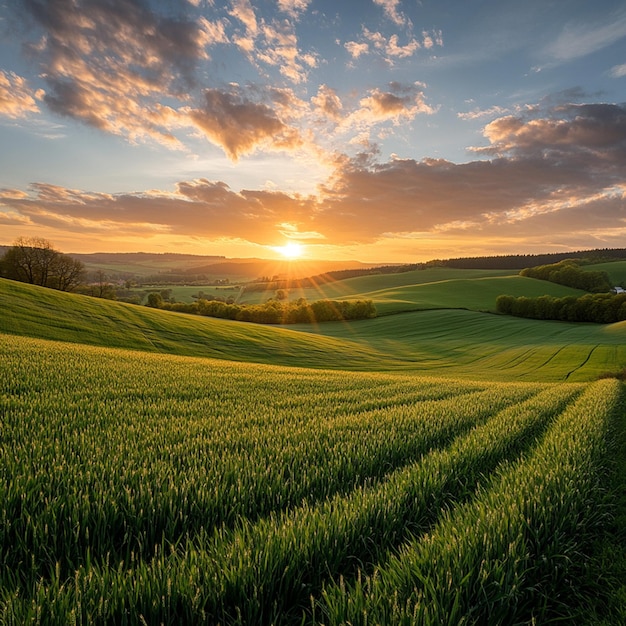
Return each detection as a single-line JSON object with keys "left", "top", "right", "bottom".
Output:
{"left": 147, "top": 293, "right": 376, "bottom": 324}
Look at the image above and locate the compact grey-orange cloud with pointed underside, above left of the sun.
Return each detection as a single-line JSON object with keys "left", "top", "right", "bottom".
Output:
{"left": 187, "top": 86, "right": 302, "bottom": 161}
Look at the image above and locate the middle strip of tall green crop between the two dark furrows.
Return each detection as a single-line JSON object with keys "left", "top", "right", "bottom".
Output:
{"left": 48, "top": 380, "right": 577, "bottom": 624}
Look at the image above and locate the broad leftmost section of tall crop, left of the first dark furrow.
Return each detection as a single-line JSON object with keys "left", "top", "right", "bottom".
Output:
{"left": 0, "top": 339, "right": 537, "bottom": 583}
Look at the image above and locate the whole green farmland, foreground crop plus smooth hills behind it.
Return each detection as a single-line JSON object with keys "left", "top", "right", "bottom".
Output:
{"left": 0, "top": 270, "right": 626, "bottom": 626}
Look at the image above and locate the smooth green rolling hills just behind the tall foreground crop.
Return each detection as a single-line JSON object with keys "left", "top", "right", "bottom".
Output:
{"left": 0, "top": 270, "right": 626, "bottom": 381}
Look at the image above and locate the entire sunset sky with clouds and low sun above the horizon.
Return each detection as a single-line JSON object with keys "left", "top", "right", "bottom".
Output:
{"left": 0, "top": 0, "right": 626, "bottom": 263}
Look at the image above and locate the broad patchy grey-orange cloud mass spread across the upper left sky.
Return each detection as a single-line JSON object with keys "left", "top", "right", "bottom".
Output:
{"left": 9, "top": 0, "right": 432, "bottom": 166}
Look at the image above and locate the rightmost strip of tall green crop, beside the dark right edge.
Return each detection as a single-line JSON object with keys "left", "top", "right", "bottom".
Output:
{"left": 316, "top": 381, "right": 623, "bottom": 625}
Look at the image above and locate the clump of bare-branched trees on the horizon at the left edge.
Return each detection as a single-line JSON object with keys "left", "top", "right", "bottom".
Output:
{"left": 2, "top": 237, "right": 84, "bottom": 291}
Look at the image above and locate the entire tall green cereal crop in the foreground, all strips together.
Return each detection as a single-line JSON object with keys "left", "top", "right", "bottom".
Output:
{"left": 0, "top": 336, "right": 608, "bottom": 624}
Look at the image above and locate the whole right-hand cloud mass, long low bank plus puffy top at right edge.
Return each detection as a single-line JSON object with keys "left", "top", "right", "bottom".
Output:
{"left": 316, "top": 101, "right": 626, "bottom": 242}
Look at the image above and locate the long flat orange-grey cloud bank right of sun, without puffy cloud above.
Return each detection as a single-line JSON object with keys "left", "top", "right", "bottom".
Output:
{"left": 314, "top": 152, "right": 626, "bottom": 244}
